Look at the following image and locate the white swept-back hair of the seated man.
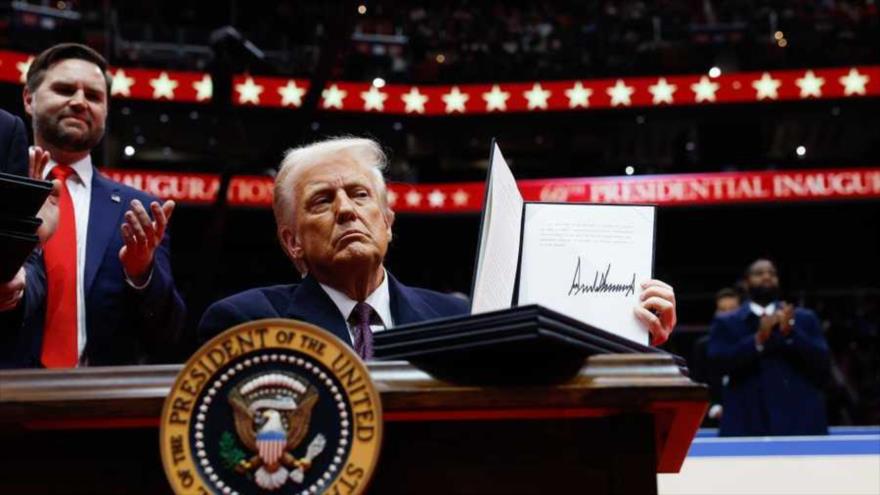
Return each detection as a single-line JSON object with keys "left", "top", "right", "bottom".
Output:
{"left": 272, "top": 136, "right": 388, "bottom": 273}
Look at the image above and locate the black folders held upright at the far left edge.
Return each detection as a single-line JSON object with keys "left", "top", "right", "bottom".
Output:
{"left": 0, "top": 173, "right": 52, "bottom": 282}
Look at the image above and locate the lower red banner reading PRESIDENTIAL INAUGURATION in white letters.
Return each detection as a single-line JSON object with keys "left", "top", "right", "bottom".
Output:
{"left": 105, "top": 168, "right": 880, "bottom": 214}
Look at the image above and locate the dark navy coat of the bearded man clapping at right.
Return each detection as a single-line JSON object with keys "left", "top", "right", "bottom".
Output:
{"left": 708, "top": 301, "right": 830, "bottom": 436}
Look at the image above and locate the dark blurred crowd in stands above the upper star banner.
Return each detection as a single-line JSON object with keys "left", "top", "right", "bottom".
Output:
{"left": 6, "top": 0, "right": 880, "bottom": 83}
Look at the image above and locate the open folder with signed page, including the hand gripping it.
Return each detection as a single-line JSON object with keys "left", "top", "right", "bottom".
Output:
{"left": 471, "top": 144, "right": 676, "bottom": 344}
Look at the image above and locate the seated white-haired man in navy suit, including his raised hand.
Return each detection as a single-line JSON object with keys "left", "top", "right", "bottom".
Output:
{"left": 198, "top": 138, "right": 675, "bottom": 359}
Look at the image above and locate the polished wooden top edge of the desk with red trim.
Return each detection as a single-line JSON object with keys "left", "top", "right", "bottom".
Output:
{"left": 0, "top": 354, "right": 708, "bottom": 472}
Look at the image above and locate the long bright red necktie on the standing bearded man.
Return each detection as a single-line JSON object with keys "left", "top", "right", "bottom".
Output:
{"left": 41, "top": 165, "right": 79, "bottom": 368}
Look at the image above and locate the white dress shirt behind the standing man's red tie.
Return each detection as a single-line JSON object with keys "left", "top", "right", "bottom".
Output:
{"left": 43, "top": 155, "right": 94, "bottom": 362}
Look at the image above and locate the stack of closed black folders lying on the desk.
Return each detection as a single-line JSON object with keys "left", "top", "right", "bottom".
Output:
{"left": 373, "top": 305, "right": 687, "bottom": 385}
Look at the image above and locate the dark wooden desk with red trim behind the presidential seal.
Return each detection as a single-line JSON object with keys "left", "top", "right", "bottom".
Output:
{"left": 0, "top": 355, "right": 708, "bottom": 494}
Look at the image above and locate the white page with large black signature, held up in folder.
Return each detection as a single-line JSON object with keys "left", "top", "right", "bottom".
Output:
{"left": 517, "top": 203, "right": 655, "bottom": 345}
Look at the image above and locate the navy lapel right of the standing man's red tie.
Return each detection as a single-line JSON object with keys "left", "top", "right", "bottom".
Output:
{"left": 85, "top": 169, "right": 123, "bottom": 294}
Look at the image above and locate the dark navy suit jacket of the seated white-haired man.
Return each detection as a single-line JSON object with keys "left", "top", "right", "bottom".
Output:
{"left": 198, "top": 273, "right": 470, "bottom": 344}
